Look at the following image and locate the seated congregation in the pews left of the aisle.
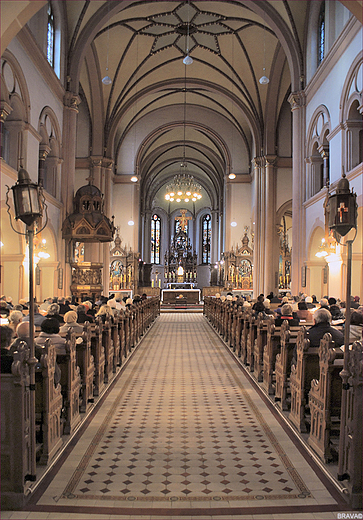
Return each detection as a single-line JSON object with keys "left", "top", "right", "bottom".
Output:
{"left": 0, "top": 294, "right": 146, "bottom": 373}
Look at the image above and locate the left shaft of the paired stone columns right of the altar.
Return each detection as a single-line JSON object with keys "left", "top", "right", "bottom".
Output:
{"left": 253, "top": 157, "right": 265, "bottom": 298}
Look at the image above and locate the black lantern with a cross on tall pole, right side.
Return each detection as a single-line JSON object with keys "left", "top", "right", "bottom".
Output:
{"left": 329, "top": 173, "right": 360, "bottom": 481}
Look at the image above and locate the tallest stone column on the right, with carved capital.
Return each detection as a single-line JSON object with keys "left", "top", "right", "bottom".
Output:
{"left": 288, "top": 91, "right": 306, "bottom": 294}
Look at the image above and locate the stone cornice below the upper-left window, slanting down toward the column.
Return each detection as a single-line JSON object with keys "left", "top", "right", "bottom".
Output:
{"left": 17, "top": 25, "right": 65, "bottom": 103}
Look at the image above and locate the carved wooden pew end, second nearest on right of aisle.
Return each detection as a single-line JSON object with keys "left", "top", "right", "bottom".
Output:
{"left": 308, "top": 333, "right": 343, "bottom": 462}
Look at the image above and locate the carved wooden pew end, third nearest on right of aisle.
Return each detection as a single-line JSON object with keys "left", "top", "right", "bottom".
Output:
{"left": 289, "top": 327, "right": 319, "bottom": 432}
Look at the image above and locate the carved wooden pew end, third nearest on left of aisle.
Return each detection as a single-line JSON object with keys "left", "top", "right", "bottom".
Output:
{"left": 57, "top": 331, "right": 81, "bottom": 435}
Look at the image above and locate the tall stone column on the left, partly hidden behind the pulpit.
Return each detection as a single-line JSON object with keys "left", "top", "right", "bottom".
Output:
{"left": 61, "top": 92, "right": 81, "bottom": 293}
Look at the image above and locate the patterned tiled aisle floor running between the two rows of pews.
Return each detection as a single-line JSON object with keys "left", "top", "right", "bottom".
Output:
{"left": 1, "top": 313, "right": 354, "bottom": 520}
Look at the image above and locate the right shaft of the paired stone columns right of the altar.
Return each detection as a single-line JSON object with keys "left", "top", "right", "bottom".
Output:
{"left": 263, "top": 155, "right": 278, "bottom": 296}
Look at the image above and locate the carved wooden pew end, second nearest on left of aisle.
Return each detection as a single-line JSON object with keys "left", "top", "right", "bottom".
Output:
{"left": 35, "top": 339, "right": 63, "bottom": 465}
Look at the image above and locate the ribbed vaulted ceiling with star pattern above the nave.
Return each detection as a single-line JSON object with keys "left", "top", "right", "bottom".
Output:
{"left": 65, "top": 0, "right": 309, "bottom": 211}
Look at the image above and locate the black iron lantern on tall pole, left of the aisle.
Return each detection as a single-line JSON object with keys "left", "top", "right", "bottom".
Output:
{"left": 6, "top": 168, "right": 48, "bottom": 481}
